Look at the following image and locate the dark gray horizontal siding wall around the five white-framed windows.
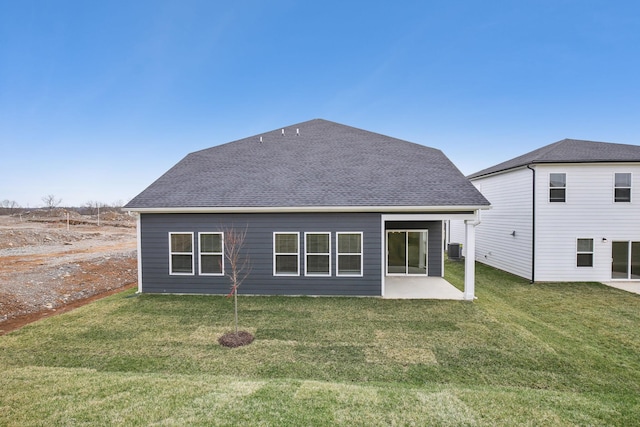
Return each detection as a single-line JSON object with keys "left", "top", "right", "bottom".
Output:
{"left": 141, "top": 213, "right": 382, "bottom": 295}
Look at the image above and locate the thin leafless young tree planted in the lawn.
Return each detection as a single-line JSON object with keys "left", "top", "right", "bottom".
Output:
{"left": 223, "top": 227, "right": 251, "bottom": 335}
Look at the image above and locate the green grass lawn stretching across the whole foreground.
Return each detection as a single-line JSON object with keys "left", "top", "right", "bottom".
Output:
{"left": 0, "top": 263, "right": 640, "bottom": 426}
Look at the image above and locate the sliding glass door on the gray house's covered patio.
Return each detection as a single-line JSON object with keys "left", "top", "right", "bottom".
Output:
{"left": 387, "top": 230, "right": 428, "bottom": 276}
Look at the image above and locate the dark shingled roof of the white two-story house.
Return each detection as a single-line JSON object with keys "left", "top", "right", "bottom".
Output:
{"left": 468, "top": 139, "right": 640, "bottom": 179}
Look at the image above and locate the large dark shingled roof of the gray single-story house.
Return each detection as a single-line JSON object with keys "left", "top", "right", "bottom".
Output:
{"left": 126, "top": 119, "right": 489, "bottom": 209}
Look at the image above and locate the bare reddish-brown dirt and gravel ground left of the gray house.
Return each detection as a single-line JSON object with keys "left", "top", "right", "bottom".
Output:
{"left": 0, "top": 216, "right": 137, "bottom": 334}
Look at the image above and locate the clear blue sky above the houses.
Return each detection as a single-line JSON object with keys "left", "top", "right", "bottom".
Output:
{"left": 0, "top": 0, "right": 640, "bottom": 207}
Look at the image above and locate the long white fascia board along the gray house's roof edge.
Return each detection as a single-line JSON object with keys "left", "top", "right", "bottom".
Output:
{"left": 125, "top": 206, "right": 490, "bottom": 219}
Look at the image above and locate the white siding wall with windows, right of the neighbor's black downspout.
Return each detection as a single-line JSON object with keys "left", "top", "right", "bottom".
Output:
{"left": 536, "top": 163, "right": 640, "bottom": 282}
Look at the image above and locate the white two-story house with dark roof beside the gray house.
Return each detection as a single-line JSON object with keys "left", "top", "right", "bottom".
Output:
{"left": 450, "top": 140, "right": 640, "bottom": 282}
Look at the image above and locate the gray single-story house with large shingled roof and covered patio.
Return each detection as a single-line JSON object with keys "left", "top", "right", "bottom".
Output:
{"left": 125, "top": 119, "right": 489, "bottom": 300}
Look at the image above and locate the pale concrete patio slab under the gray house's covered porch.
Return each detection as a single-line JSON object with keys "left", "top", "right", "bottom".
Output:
{"left": 384, "top": 276, "right": 464, "bottom": 301}
